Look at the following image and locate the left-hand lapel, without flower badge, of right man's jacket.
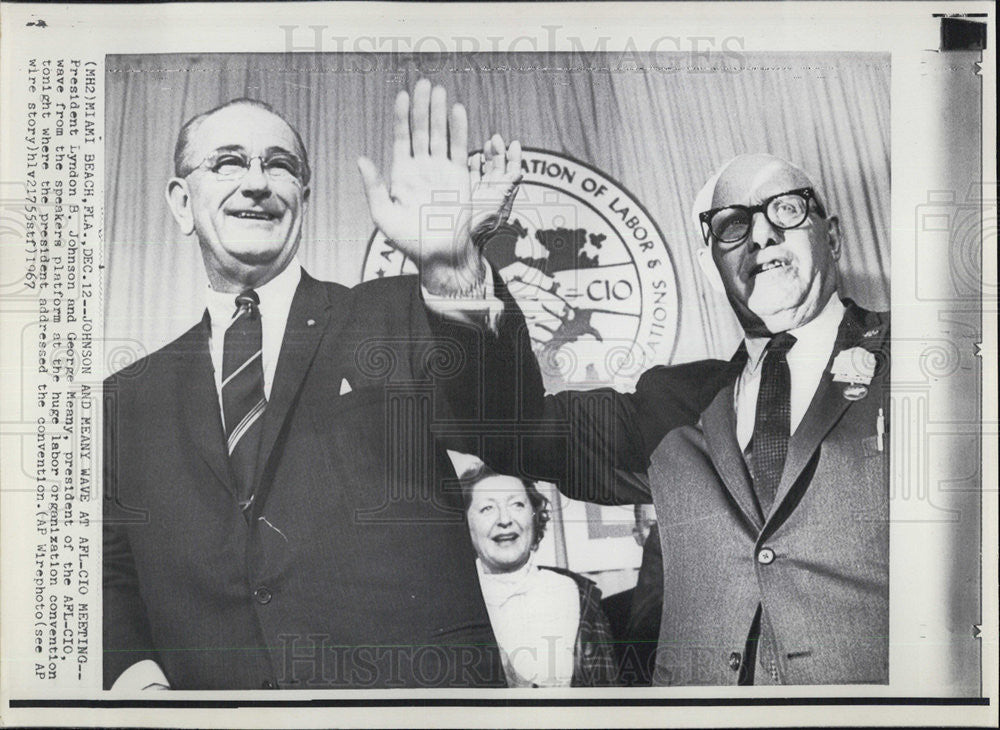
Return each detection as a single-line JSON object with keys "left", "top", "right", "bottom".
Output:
{"left": 701, "top": 382, "right": 764, "bottom": 531}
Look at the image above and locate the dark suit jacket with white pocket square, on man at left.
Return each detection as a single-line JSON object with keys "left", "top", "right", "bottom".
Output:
{"left": 104, "top": 274, "right": 516, "bottom": 689}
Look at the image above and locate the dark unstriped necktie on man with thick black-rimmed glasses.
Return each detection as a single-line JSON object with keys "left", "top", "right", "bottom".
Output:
{"left": 751, "top": 332, "right": 795, "bottom": 517}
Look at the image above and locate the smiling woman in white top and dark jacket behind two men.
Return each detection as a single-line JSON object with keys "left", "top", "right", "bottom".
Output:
{"left": 462, "top": 466, "right": 617, "bottom": 687}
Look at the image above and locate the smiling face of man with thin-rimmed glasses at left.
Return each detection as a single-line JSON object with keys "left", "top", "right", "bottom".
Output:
{"left": 167, "top": 104, "right": 309, "bottom": 292}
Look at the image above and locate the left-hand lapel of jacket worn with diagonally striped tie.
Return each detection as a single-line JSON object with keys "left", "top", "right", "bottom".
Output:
{"left": 175, "top": 311, "right": 235, "bottom": 494}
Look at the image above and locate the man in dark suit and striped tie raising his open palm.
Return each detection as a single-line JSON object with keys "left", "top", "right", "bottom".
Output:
{"left": 104, "top": 81, "right": 519, "bottom": 689}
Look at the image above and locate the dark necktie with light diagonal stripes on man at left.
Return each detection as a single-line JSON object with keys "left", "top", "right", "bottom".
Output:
{"left": 222, "top": 289, "right": 267, "bottom": 510}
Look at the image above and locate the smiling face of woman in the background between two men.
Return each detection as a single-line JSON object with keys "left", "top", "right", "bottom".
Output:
{"left": 466, "top": 476, "right": 535, "bottom": 573}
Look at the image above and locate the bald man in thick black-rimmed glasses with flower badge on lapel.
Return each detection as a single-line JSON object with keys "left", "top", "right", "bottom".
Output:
{"left": 483, "top": 148, "right": 889, "bottom": 685}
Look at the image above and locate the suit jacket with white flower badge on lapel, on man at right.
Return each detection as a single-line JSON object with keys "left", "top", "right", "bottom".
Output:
{"left": 483, "top": 294, "right": 889, "bottom": 684}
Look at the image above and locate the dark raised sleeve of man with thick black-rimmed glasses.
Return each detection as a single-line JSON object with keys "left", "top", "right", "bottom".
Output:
{"left": 426, "top": 276, "right": 733, "bottom": 504}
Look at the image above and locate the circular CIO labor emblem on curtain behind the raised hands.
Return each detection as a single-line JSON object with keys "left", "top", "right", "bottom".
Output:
{"left": 362, "top": 148, "right": 678, "bottom": 392}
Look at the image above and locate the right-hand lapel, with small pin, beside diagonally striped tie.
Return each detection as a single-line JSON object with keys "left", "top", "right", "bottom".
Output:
{"left": 253, "top": 271, "right": 348, "bottom": 498}
